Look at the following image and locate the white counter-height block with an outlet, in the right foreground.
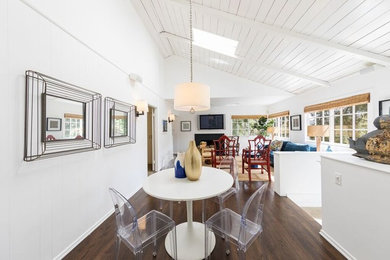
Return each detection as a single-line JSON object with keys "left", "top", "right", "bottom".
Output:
{"left": 320, "top": 154, "right": 390, "bottom": 259}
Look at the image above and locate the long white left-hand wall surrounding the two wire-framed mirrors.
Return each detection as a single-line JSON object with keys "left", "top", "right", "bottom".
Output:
{"left": 0, "top": 0, "right": 172, "bottom": 259}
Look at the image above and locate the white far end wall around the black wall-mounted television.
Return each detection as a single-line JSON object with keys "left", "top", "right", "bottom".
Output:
{"left": 173, "top": 106, "right": 267, "bottom": 152}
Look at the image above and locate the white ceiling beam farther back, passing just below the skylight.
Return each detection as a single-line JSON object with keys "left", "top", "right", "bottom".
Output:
{"left": 160, "top": 31, "right": 330, "bottom": 87}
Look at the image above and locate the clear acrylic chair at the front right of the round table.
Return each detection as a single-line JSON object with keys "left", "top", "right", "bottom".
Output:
{"left": 205, "top": 184, "right": 267, "bottom": 259}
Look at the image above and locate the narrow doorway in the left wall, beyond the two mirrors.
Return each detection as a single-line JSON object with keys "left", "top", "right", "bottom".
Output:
{"left": 147, "top": 106, "right": 157, "bottom": 175}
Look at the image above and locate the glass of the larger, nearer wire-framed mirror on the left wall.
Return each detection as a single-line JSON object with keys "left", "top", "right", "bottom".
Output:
{"left": 44, "top": 95, "right": 85, "bottom": 141}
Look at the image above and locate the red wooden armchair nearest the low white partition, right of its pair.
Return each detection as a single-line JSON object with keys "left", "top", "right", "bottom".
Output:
{"left": 242, "top": 135, "right": 271, "bottom": 181}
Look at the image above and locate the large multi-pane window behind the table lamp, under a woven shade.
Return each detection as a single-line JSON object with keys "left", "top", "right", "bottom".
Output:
{"left": 306, "top": 103, "right": 368, "bottom": 144}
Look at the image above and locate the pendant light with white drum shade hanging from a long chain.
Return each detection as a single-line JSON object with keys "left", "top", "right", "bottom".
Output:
{"left": 173, "top": 0, "right": 210, "bottom": 113}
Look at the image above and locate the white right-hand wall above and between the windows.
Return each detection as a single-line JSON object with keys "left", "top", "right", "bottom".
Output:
{"left": 269, "top": 68, "right": 390, "bottom": 146}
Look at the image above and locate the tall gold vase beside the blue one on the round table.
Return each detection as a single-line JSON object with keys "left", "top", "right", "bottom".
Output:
{"left": 184, "top": 141, "right": 202, "bottom": 181}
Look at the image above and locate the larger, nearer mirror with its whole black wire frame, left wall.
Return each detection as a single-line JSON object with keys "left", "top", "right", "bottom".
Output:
{"left": 24, "top": 71, "right": 102, "bottom": 162}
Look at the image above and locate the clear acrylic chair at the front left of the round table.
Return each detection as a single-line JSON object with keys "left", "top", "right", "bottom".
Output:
{"left": 109, "top": 188, "right": 177, "bottom": 259}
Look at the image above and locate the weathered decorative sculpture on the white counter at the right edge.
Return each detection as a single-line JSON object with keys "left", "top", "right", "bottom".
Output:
{"left": 349, "top": 115, "right": 390, "bottom": 164}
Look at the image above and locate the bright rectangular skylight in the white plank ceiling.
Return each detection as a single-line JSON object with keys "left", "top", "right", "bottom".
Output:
{"left": 192, "top": 28, "right": 238, "bottom": 58}
